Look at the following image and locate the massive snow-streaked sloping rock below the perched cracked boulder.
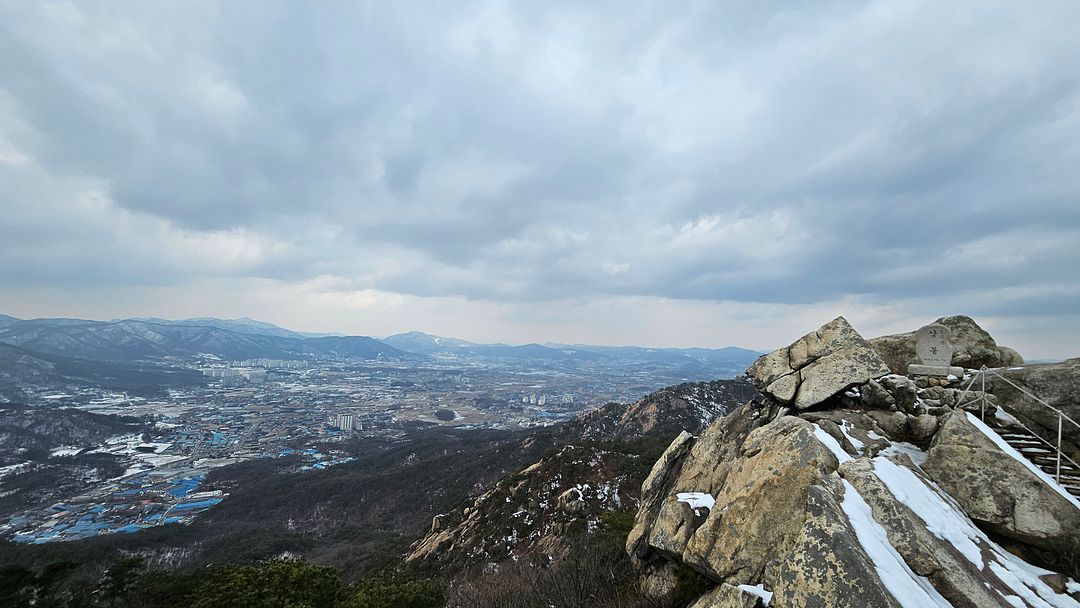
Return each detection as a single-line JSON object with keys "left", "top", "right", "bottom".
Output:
{"left": 626, "top": 403, "right": 1080, "bottom": 608}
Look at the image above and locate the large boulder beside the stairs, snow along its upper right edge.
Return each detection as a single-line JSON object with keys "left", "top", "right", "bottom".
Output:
{"left": 922, "top": 409, "right": 1080, "bottom": 555}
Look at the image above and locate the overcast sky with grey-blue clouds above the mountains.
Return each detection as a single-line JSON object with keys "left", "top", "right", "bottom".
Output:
{"left": 0, "top": 0, "right": 1080, "bottom": 357}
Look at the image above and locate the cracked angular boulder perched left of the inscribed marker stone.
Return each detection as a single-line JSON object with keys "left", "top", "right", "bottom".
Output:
{"left": 746, "top": 316, "right": 889, "bottom": 409}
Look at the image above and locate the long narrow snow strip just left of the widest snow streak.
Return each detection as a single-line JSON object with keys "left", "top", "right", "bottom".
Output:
{"left": 840, "top": 479, "right": 953, "bottom": 608}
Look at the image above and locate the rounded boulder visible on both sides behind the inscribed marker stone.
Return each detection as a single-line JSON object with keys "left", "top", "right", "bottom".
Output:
{"left": 869, "top": 314, "right": 1024, "bottom": 374}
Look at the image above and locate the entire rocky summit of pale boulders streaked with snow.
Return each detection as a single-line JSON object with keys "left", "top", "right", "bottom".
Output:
{"left": 626, "top": 317, "right": 1080, "bottom": 608}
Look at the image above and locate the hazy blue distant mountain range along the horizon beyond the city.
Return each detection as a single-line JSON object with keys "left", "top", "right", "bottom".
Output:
{"left": 0, "top": 315, "right": 759, "bottom": 376}
